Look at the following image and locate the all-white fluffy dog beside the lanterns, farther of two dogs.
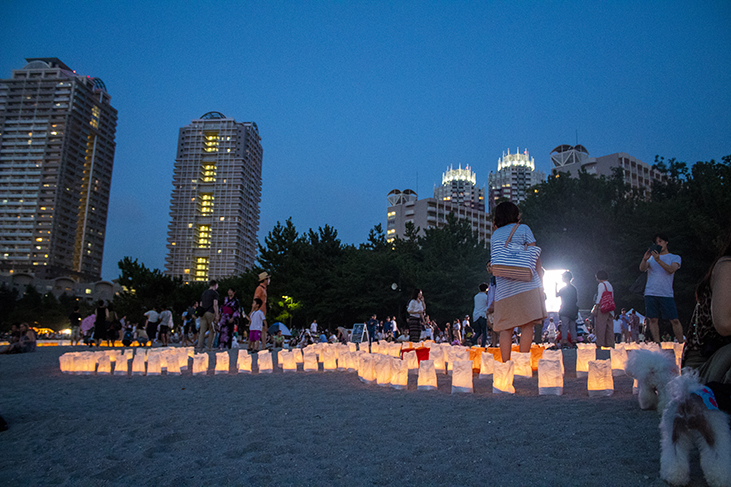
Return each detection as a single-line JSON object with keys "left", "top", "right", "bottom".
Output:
{"left": 625, "top": 349, "right": 678, "bottom": 412}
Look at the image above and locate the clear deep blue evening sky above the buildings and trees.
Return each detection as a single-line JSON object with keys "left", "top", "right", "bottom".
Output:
{"left": 0, "top": 0, "right": 731, "bottom": 279}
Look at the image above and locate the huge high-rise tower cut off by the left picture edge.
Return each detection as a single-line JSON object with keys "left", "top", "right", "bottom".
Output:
{"left": 0, "top": 58, "right": 117, "bottom": 281}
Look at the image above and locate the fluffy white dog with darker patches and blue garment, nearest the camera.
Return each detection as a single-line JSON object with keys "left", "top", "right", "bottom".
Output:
{"left": 660, "top": 369, "right": 731, "bottom": 487}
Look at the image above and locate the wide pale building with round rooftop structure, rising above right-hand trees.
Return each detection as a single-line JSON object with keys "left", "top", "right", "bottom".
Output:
{"left": 551, "top": 144, "right": 667, "bottom": 197}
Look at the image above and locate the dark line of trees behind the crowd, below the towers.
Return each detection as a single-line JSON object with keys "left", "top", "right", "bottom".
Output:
{"left": 0, "top": 156, "right": 731, "bottom": 334}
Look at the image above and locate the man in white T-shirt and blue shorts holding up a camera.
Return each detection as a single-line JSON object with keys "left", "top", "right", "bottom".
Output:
{"left": 640, "top": 234, "right": 684, "bottom": 343}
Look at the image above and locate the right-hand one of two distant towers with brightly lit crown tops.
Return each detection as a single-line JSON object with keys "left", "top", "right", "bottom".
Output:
{"left": 488, "top": 149, "right": 546, "bottom": 213}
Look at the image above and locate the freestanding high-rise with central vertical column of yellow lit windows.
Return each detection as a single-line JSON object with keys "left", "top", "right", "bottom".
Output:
{"left": 165, "top": 112, "right": 262, "bottom": 282}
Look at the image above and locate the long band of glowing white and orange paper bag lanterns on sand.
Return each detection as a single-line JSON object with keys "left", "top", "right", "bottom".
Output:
{"left": 59, "top": 342, "right": 682, "bottom": 396}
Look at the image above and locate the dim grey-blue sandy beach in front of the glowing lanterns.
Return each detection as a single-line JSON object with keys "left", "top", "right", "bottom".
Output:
{"left": 0, "top": 347, "right": 706, "bottom": 486}
